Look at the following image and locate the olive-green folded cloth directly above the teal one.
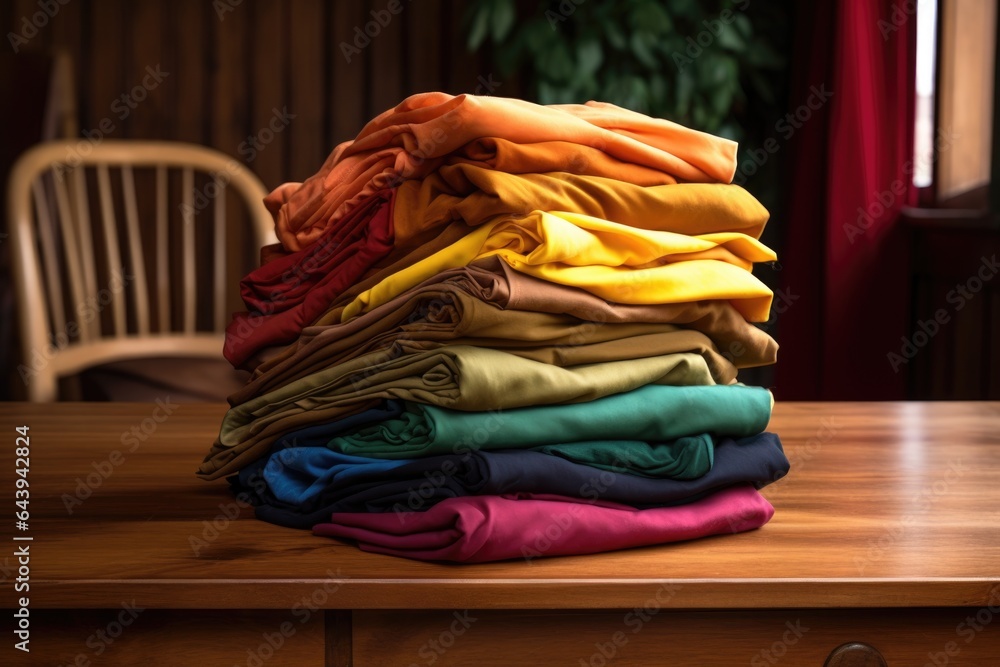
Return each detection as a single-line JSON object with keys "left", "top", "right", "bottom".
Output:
{"left": 199, "top": 345, "right": 715, "bottom": 479}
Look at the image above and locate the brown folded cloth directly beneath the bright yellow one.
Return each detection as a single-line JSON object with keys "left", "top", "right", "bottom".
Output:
{"left": 229, "top": 257, "right": 777, "bottom": 405}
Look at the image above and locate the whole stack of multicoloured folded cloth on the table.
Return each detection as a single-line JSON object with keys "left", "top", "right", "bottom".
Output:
{"left": 199, "top": 93, "right": 788, "bottom": 562}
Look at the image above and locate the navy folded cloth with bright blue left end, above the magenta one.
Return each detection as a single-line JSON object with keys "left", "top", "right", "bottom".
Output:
{"left": 236, "top": 433, "right": 789, "bottom": 528}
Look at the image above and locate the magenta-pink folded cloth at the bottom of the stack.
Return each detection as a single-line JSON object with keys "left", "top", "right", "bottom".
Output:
{"left": 313, "top": 485, "right": 774, "bottom": 563}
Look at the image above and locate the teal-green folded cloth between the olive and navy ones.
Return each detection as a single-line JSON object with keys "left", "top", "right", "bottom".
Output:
{"left": 327, "top": 384, "right": 771, "bottom": 459}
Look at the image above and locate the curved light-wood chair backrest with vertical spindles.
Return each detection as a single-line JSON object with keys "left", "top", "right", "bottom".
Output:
{"left": 7, "top": 139, "right": 276, "bottom": 402}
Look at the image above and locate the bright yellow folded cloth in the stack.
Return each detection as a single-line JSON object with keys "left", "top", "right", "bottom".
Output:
{"left": 341, "top": 211, "right": 776, "bottom": 322}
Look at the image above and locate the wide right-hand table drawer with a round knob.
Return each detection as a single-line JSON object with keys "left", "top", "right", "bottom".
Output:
{"left": 353, "top": 603, "right": 1000, "bottom": 667}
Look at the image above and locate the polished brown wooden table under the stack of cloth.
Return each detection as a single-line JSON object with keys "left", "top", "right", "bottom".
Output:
{"left": 0, "top": 403, "right": 1000, "bottom": 667}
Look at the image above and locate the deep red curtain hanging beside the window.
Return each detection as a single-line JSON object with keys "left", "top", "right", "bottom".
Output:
{"left": 775, "top": 0, "right": 917, "bottom": 400}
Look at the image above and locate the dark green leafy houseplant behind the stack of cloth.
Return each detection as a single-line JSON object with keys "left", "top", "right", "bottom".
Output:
{"left": 465, "top": 0, "right": 787, "bottom": 147}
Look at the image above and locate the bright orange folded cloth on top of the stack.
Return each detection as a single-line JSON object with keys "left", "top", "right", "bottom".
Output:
{"left": 265, "top": 93, "right": 736, "bottom": 251}
